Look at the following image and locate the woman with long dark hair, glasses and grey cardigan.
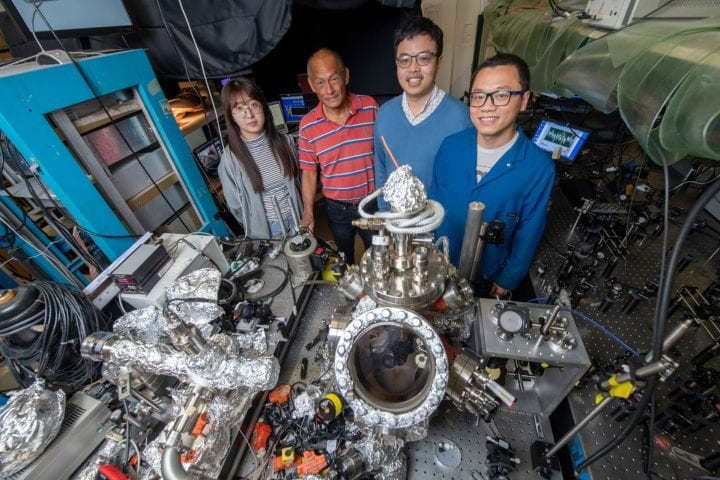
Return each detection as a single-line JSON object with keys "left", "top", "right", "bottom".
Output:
{"left": 218, "top": 78, "right": 302, "bottom": 238}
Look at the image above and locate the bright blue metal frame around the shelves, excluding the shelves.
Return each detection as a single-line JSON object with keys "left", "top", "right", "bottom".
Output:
{"left": 0, "top": 50, "right": 228, "bottom": 268}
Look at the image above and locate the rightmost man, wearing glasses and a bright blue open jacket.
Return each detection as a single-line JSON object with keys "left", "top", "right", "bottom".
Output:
{"left": 429, "top": 54, "right": 555, "bottom": 298}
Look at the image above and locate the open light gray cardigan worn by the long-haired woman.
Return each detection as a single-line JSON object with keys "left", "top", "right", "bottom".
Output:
{"left": 218, "top": 145, "right": 302, "bottom": 238}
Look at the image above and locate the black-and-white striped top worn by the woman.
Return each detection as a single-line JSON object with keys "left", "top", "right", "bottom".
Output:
{"left": 245, "top": 133, "right": 290, "bottom": 221}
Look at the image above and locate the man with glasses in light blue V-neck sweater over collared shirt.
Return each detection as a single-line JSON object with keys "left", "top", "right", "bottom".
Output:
{"left": 375, "top": 17, "right": 471, "bottom": 209}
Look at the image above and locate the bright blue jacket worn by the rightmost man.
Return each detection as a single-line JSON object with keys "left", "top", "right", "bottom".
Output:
{"left": 428, "top": 127, "right": 555, "bottom": 290}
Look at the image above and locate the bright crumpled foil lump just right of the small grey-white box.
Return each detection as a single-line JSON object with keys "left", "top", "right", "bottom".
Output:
{"left": 165, "top": 268, "right": 223, "bottom": 325}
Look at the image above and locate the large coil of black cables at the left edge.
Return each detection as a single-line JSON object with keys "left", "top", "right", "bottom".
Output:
{"left": 0, "top": 281, "right": 110, "bottom": 388}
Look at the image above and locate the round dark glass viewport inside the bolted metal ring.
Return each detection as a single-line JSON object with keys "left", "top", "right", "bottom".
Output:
{"left": 348, "top": 323, "right": 435, "bottom": 413}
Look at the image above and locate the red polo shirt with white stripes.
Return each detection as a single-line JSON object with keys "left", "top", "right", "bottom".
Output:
{"left": 298, "top": 94, "right": 378, "bottom": 203}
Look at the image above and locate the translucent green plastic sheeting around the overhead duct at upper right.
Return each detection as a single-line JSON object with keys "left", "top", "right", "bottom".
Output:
{"left": 481, "top": 0, "right": 720, "bottom": 164}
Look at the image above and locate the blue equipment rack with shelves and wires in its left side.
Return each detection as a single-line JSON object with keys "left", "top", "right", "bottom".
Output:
{"left": 0, "top": 50, "right": 228, "bottom": 283}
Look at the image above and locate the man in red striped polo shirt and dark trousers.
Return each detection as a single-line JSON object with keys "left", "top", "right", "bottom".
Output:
{"left": 299, "top": 49, "right": 378, "bottom": 263}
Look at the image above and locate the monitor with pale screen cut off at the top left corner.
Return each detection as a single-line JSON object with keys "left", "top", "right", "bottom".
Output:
{"left": 4, "top": 0, "right": 132, "bottom": 38}
